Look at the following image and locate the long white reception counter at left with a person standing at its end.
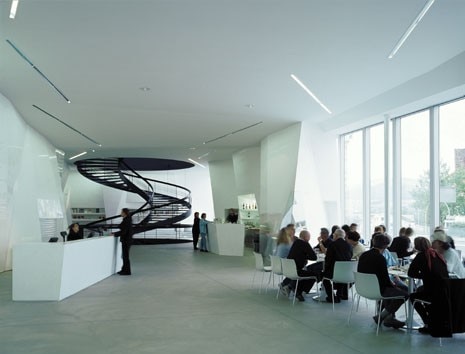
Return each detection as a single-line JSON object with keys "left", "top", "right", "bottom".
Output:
{"left": 13, "top": 236, "right": 122, "bottom": 301}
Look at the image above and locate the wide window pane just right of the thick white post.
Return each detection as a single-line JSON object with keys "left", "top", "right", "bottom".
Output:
{"left": 394, "top": 111, "right": 431, "bottom": 236}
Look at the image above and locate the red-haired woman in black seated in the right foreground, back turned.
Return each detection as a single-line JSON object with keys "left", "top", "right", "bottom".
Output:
{"left": 408, "top": 237, "right": 449, "bottom": 333}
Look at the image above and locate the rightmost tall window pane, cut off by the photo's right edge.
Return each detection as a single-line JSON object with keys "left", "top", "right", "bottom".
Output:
{"left": 439, "top": 100, "right": 465, "bottom": 250}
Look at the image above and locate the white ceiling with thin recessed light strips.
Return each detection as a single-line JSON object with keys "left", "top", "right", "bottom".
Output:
{"left": 0, "top": 0, "right": 465, "bottom": 160}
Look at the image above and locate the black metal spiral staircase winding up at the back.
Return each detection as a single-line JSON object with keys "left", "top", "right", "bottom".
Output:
{"left": 75, "top": 158, "right": 192, "bottom": 233}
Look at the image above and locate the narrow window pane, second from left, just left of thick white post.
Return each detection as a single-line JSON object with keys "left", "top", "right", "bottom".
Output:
{"left": 366, "top": 124, "right": 386, "bottom": 236}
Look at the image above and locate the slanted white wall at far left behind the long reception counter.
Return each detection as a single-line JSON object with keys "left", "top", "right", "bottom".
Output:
{"left": 0, "top": 94, "right": 67, "bottom": 271}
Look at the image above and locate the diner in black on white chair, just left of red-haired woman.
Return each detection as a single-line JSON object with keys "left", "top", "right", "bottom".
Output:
{"left": 357, "top": 234, "right": 408, "bottom": 328}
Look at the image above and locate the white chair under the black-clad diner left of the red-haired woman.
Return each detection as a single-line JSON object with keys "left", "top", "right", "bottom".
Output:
{"left": 347, "top": 272, "right": 407, "bottom": 335}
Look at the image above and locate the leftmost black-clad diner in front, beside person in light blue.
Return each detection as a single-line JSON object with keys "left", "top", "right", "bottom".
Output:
{"left": 280, "top": 230, "right": 321, "bottom": 301}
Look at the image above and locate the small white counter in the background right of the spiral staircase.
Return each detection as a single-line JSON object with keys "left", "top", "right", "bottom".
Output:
{"left": 208, "top": 224, "right": 244, "bottom": 256}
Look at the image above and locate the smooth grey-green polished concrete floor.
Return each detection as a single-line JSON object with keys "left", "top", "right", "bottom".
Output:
{"left": 0, "top": 244, "right": 465, "bottom": 354}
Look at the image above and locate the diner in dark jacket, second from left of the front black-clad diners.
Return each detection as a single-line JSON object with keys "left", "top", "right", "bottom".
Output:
{"left": 323, "top": 229, "right": 352, "bottom": 303}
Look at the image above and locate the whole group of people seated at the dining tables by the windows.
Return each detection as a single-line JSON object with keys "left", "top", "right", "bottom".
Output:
{"left": 275, "top": 223, "right": 465, "bottom": 333}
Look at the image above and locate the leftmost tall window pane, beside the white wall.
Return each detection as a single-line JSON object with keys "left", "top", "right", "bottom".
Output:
{"left": 344, "top": 131, "right": 364, "bottom": 235}
